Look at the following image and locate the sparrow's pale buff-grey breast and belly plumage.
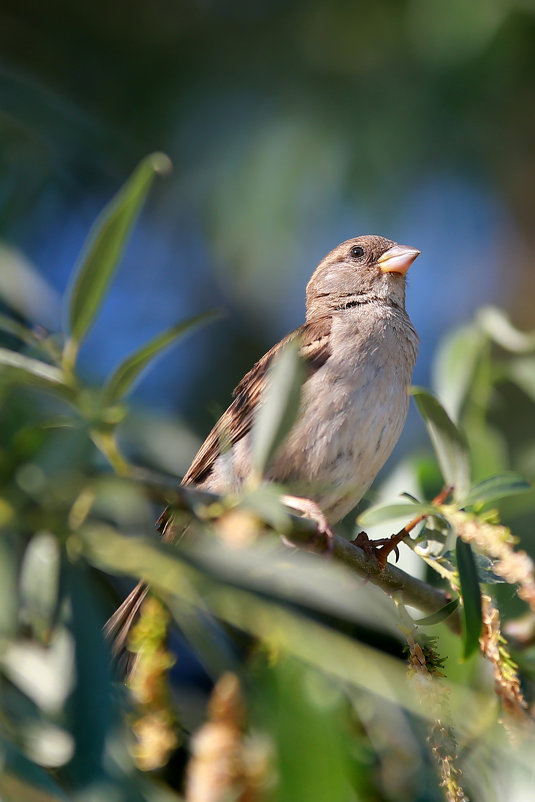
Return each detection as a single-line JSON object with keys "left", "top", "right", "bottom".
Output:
{"left": 271, "top": 310, "right": 416, "bottom": 522}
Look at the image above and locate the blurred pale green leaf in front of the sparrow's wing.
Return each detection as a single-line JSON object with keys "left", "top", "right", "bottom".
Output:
{"left": 252, "top": 340, "right": 304, "bottom": 475}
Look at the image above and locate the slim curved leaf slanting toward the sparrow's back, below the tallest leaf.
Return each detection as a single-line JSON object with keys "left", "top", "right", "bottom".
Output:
{"left": 104, "top": 310, "right": 219, "bottom": 403}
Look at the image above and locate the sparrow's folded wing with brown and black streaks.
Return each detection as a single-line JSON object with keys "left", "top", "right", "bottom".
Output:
{"left": 182, "top": 315, "right": 332, "bottom": 485}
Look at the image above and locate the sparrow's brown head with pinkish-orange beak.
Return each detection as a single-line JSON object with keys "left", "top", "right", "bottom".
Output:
{"left": 307, "top": 234, "right": 420, "bottom": 318}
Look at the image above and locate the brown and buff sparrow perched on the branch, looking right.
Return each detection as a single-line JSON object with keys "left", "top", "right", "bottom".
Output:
{"left": 105, "top": 235, "right": 420, "bottom": 654}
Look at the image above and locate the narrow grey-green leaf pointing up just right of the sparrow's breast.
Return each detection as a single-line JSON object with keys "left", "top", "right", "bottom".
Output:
{"left": 411, "top": 387, "right": 470, "bottom": 500}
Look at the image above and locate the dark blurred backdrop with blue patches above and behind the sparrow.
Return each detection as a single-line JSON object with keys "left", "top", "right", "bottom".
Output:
{"left": 0, "top": 0, "right": 535, "bottom": 469}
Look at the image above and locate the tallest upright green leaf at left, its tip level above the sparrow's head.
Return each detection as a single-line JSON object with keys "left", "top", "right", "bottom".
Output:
{"left": 68, "top": 153, "right": 171, "bottom": 349}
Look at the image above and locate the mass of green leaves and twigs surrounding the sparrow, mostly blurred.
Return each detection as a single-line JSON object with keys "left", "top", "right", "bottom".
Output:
{"left": 0, "top": 155, "right": 535, "bottom": 802}
